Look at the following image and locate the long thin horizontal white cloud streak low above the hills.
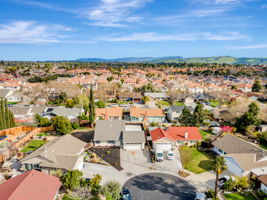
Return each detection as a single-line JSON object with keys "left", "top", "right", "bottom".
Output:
{"left": 96, "top": 32, "right": 247, "bottom": 42}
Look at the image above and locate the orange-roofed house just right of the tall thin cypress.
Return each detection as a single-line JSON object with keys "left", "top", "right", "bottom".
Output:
{"left": 95, "top": 107, "right": 123, "bottom": 120}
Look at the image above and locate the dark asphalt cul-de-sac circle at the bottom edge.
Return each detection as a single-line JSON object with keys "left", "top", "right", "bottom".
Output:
{"left": 124, "top": 173, "right": 196, "bottom": 200}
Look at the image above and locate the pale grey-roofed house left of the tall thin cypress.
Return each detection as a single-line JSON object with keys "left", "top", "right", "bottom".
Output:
{"left": 44, "top": 106, "right": 83, "bottom": 121}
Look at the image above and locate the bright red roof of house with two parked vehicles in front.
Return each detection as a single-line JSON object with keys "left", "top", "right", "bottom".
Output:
{"left": 150, "top": 127, "right": 202, "bottom": 141}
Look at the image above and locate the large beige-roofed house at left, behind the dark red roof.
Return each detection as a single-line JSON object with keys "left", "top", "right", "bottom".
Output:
{"left": 20, "top": 134, "right": 86, "bottom": 173}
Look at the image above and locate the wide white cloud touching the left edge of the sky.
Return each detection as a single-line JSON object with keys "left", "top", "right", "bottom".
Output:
{"left": 0, "top": 21, "right": 72, "bottom": 44}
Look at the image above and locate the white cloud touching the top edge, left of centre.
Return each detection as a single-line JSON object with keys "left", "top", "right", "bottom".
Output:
{"left": 82, "top": 0, "right": 152, "bottom": 27}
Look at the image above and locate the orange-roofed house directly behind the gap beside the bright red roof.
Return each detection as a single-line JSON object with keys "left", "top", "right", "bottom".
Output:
{"left": 130, "top": 107, "right": 165, "bottom": 123}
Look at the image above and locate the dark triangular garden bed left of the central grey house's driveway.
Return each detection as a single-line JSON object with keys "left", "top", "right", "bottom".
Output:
{"left": 89, "top": 147, "right": 122, "bottom": 170}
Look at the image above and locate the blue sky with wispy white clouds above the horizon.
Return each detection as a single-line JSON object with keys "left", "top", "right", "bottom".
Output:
{"left": 0, "top": 0, "right": 267, "bottom": 60}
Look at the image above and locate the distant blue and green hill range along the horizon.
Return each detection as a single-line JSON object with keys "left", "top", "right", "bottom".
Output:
{"left": 76, "top": 56, "right": 267, "bottom": 64}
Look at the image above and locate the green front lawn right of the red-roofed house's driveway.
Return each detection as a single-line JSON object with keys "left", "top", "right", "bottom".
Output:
{"left": 180, "top": 147, "right": 214, "bottom": 174}
